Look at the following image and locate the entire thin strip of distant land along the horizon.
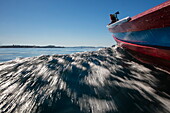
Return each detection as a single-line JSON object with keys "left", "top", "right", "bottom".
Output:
{"left": 0, "top": 45, "right": 104, "bottom": 48}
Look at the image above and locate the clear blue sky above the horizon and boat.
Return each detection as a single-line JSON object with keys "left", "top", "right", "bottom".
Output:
{"left": 0, "top": 0, "right": 167, "bottom": 46}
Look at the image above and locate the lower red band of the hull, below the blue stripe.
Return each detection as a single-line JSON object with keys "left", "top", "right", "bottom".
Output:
{"left": 115, "top": 38, "right": 170, "bottom": 72}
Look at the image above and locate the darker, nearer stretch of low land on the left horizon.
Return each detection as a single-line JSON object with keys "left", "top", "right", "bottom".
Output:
{"left": 0, "top": 45, "right": 65, "bottom": 48}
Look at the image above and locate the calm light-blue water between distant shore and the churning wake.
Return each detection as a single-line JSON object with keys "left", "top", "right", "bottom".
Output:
{"left": 0, "top": 47, "right": 101, "bottom": 62}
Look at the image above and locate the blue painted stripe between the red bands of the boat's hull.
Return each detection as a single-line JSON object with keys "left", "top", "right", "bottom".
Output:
{"left": 113, "top": 27, "right": 170, "bottom": 47}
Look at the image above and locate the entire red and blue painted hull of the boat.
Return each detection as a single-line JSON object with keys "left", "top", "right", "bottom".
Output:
{"left": 109, "top": 0, "right": 170, "bottom": 72}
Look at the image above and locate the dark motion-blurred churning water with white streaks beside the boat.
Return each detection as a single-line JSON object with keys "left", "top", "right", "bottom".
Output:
{"left": 0, "top": 46, "right": 170, "bottom": 113}
